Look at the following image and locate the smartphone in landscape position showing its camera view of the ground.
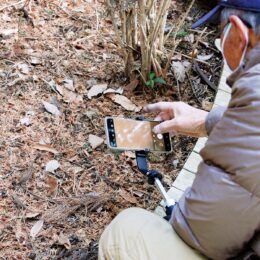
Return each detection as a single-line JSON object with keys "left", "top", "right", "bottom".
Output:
{"left": 105, "top": 117, "right": 172, "bottom": 153}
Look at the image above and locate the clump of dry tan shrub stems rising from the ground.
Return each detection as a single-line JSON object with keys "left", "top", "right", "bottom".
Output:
{"left": 107, "top": 0, "right": 195, "bottom": 83}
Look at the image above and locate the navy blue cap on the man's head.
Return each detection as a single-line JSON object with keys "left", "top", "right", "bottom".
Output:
{"left": 192, "top": 0, "right": 260, "bottom": 29}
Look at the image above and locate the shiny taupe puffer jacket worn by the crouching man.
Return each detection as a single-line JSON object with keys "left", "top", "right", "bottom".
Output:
{"left": 170, "top": 64, "right": 260, "bottom": 259}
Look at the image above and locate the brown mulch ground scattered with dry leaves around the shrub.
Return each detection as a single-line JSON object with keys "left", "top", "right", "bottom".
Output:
{"left": 0, "top": 0, "right": 221, "bottom": 259}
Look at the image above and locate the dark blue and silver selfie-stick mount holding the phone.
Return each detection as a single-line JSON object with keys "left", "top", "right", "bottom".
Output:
{"left": 135, "top": 117, "right": 175, "bottom": 220}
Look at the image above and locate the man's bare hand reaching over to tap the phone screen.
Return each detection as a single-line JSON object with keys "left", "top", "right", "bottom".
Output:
{"left": 144, "top": 102, "right": 208, "bottom": 137}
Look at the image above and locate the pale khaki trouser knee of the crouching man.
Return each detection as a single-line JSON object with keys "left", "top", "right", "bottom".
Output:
{"left": 99, "top": 208, "right": 206, "bottom": 260}
